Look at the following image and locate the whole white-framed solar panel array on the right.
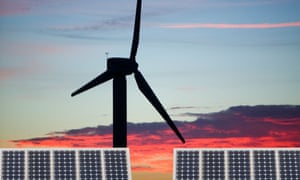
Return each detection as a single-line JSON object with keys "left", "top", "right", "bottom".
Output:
{"left": 173, "top": 148, "right": 300, "bottom": 180}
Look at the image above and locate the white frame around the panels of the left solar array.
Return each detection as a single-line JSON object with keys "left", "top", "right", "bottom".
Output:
{"left": 0, "top": 148, "right": 132, "bottom": 180}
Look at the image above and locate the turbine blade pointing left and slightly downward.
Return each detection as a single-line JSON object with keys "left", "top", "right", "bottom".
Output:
{"left": 71, "top": 71, "right": 113, "bottom": 96}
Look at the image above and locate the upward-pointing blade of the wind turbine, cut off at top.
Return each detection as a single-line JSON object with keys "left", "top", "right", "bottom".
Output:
{"left": 130, "top": 0, "right": 142, "bottom": 60}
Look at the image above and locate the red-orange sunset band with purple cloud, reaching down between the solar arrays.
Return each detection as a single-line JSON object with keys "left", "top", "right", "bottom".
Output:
{"left": 2, "top": 105, "right": 300, "bottom": 179}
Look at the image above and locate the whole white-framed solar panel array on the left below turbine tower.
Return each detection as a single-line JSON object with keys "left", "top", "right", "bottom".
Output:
{"left": 0, "top": 148, "right": 131, "bottom": 180}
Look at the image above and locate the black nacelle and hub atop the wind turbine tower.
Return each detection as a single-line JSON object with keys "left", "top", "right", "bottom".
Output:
{"left": 107, "top": 57, "right": 138, "bottom": 75}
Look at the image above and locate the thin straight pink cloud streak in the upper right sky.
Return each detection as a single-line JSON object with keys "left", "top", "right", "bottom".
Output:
{"left": 160, "top": 22, "right": 300, "bottom": 29}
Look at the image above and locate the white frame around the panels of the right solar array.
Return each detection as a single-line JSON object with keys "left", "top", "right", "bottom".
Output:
{"left": 173, "top": 148, "right": 300, "bottom": 180}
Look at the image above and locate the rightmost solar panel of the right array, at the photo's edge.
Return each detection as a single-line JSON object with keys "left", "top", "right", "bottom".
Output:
{"left": 279, "top": 150, "right": 300, "bottom": 180}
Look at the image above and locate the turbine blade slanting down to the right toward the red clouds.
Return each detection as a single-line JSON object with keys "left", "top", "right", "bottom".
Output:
{"left": 134, "top": 71, "right": 185, "bottom": 143}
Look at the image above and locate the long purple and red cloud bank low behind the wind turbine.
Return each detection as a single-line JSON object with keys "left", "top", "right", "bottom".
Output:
{"left": 14, "top": 105, "right": 300, "bottom": 146}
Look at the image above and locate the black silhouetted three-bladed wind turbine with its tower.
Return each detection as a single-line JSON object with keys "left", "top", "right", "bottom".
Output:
{"left": 71, "top": 0, "right": 185, "bottom": 147}
